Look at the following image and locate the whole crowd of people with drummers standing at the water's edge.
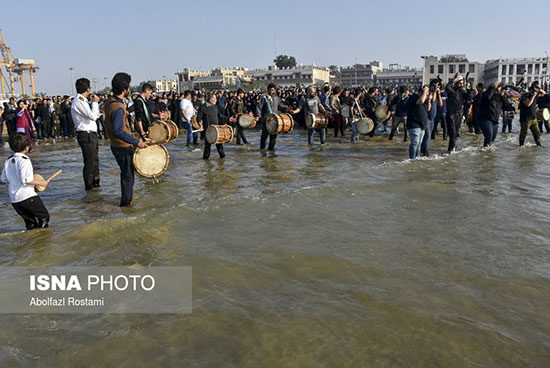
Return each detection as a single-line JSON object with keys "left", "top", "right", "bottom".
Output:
{"left": 0, "top": 73, "right": 550, "bottom": 229}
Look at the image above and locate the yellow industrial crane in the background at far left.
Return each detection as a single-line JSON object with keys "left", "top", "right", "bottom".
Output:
{"left": 0, "top": 29, "right": 40, "bottom": 98}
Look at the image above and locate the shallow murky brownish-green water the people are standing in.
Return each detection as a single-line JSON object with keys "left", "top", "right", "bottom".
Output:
{"left": 0, "top": 124, "right": 550, "bottom": 367}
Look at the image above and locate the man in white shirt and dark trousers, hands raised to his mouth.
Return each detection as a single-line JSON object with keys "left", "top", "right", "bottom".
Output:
{"left": 71, "top": 78, "right": 100, "bottom": 190}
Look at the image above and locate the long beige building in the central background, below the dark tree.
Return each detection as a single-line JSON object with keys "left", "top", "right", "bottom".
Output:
{"left": 246, "top": 65, "right": 330, "bottom": 87}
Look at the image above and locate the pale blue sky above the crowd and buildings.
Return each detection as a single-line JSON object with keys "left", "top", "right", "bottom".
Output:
{"left": 0, "top": 0, "right": 550, "bottom": 94}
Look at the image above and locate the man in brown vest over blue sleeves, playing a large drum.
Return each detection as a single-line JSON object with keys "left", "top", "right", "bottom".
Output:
{"left": 104, "top": 73, "right": 147, "bottom": 207}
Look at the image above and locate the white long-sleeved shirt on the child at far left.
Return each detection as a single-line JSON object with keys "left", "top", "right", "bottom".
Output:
{"left": 0, "top": 153, "right": 37, "bottom": 203}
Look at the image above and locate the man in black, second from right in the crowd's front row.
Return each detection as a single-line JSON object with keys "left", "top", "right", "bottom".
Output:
{"left": 479, "top": 82, "right": 514, "bottom": 147}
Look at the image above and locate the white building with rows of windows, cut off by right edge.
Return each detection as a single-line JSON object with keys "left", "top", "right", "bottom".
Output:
{"left": 483, "top": 57, "right": 548, "bottom": 85}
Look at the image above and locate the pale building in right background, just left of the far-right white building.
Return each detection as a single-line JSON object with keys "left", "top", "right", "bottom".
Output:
{"left": 422, "top": 54, "right": 484, "bottom": 85}
